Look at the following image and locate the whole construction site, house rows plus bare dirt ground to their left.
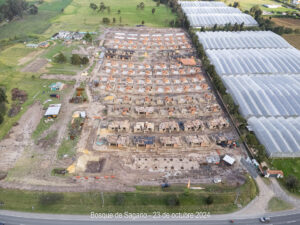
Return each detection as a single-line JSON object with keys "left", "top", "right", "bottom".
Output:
{"left": 0, "top": 27, "right": 246, "bottom": 191}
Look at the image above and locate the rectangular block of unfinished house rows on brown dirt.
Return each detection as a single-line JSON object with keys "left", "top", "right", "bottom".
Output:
{"left": 69, "top": 28, "right": 244, "bottom": 190}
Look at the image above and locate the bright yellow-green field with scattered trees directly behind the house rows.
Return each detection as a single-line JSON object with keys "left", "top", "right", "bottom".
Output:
{"left": 47, "top": 0, "right": 175, "bottom": 34}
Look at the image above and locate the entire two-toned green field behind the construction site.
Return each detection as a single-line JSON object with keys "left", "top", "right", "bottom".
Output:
{"left": 0, "top": 0, "right": 175, "bottom": 39}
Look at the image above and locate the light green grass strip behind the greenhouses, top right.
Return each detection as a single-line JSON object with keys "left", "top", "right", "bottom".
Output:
{"left": 223, "top": 0, "right": 297, "bottom": 12}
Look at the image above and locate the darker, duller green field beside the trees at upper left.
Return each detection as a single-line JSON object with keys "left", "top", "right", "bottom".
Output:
{"left": 0, "top": 0, "right": 72, "bottom": 39}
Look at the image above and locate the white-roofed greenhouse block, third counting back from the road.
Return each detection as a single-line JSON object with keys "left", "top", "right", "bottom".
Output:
{"left": 206, "top": 48, "right": 300, "bottom": 76}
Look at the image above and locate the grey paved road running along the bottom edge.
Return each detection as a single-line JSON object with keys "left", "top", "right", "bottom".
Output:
{"left": 0, "top": 211, "right": 300, "bottom": 225}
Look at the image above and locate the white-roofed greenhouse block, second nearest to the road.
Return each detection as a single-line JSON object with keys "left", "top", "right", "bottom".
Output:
{"left": 222, "top": 75, "right": 300, "bottom": 118}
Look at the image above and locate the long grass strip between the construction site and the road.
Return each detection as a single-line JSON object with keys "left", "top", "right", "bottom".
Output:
{"left": 0, "top": 179, "right": 256, "bottom": 214}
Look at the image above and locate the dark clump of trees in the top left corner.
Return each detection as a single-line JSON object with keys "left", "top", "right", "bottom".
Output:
{"left": 0, "top": 0, "right": 38, "bottom": 22}
